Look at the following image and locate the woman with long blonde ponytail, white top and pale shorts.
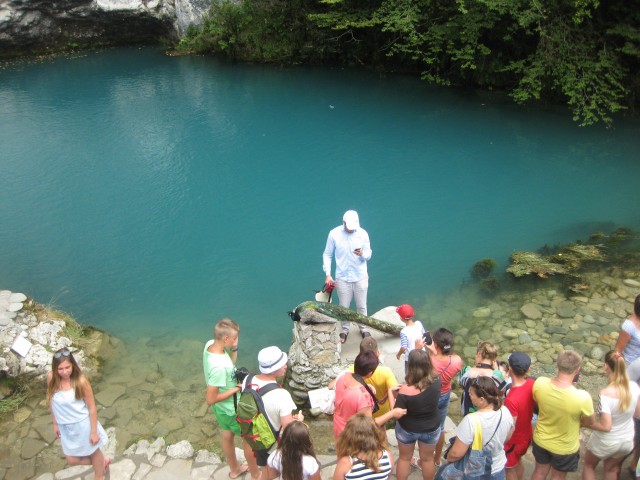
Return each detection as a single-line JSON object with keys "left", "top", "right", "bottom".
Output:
{"left": 582, "top": 350, "right": 640, "bottom": 480}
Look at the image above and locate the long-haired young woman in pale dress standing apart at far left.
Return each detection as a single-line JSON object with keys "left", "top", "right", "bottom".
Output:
{"left": 47, "top": 348, "right": 111, "bottom": 480}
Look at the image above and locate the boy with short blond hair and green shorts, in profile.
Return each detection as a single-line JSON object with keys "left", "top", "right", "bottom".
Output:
{"left": 202, "top": 318, "right": 260, "bottom": 478}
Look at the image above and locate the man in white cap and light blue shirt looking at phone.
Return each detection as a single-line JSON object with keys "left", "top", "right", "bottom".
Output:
{"left": 322, "top": 210, "right": 372, "bottom": 343}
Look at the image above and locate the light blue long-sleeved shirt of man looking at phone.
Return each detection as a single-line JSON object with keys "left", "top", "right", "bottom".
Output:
{"left": 322, "top": 225, "right": 372, "bottom": 282}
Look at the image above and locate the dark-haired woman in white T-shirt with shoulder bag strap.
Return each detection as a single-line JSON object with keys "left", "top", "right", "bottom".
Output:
{"left": 436, "top": 376, "right": 513, "bottom": 480}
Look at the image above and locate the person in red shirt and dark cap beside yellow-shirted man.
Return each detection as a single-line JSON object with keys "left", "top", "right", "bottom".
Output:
{"left": 504, "top": 352, "right": 535, "bottom": 480}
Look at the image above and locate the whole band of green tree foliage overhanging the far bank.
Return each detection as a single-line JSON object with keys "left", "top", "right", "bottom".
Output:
{"left": 178, "top": 0, "right": 640, "bottom": 125}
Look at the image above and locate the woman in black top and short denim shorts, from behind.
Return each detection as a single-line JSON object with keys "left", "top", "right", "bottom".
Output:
{"left": 392, "top": 350, "right": 441, "bottom": 480}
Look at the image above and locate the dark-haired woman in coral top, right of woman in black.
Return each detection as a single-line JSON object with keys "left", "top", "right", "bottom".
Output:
{"left": 428, "top": 328, "right": 462, "bottom": 468}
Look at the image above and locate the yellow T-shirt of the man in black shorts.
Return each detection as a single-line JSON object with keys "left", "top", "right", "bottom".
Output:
{"left": 533, "top": 377, "right": 593, "bottom": 455}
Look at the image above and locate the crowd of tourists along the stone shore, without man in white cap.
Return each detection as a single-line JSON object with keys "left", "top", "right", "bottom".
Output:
{"left": 42, "top": 295, "right": 640, "bottom": 480}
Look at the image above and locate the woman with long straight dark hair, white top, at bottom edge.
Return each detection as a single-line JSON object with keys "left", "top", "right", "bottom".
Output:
{"left": 263, "top": 420, "right": 321, "bottom": 480}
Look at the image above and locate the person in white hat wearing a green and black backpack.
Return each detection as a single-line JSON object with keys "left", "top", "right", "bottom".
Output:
{"left": 236, "top": 347, "right": 304, "bottom": 467}
